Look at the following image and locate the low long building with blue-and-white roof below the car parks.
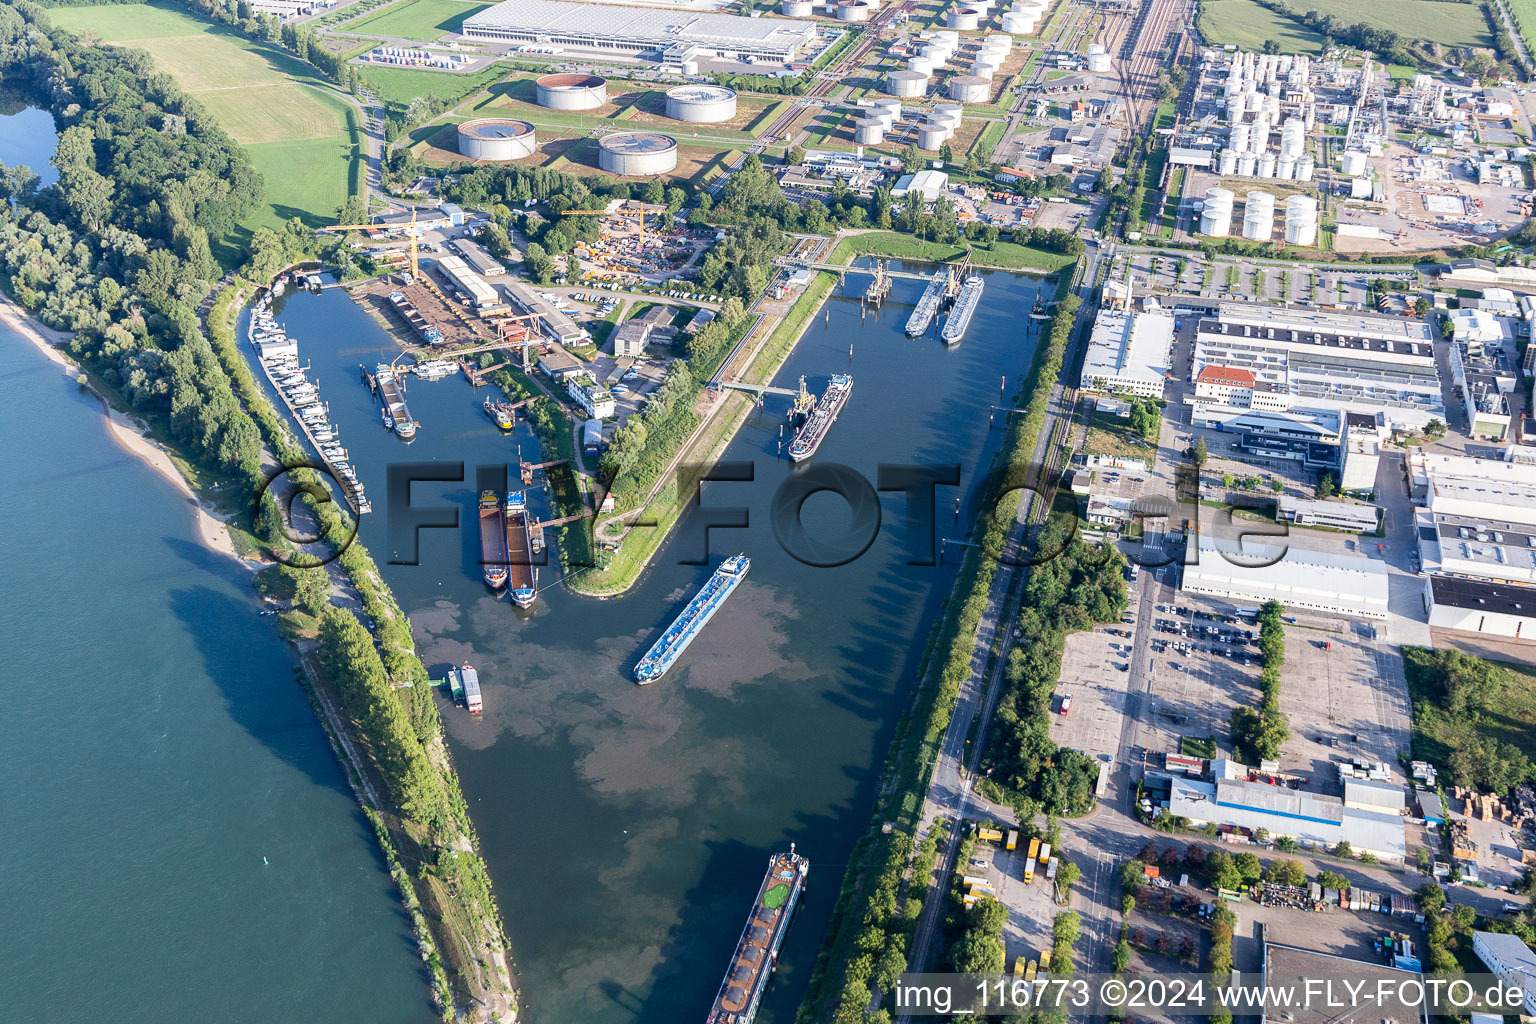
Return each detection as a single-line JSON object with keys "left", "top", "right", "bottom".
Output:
{"left": 1167, "top": 775, "right": 1407, "bottom": 864}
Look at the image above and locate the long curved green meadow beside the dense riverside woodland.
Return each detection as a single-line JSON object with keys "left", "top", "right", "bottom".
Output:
{"left": 49, "top": 3, "right": 361, "bottom": 244}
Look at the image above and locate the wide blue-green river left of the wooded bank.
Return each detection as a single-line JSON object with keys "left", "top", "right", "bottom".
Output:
{"left": 0, "top": 329, "right": 432, "bottom": 1024}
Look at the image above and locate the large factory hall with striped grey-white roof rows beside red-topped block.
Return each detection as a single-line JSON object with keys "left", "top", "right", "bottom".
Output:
{"left": 1193, "top": 302, "right": 1445, "bottom": 433}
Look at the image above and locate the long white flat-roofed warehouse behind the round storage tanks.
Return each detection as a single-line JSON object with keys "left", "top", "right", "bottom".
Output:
{"left": 461, "top": 0, "right": 816, "bottom": 63}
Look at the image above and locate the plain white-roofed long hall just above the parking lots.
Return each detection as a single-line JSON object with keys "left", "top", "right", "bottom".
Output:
{"left": 1183, "top": 534, "right": 1387, "bottom": 620}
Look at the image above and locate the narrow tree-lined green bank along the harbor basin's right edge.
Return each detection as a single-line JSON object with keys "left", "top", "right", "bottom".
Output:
{"left": 796, "top": 281, "right": 1077, "bottom": 1024}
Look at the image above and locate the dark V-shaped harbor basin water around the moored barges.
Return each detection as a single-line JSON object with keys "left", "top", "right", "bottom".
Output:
{"left": 242, "top": 273, "right": 1043, "bottom": 1024}
